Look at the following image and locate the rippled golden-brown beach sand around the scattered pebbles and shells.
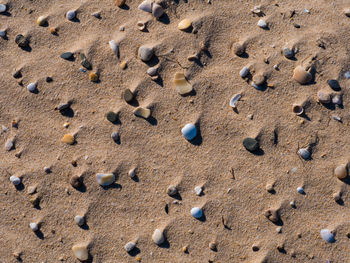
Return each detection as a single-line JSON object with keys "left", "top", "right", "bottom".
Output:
{"left": 0, "top": 0, "right": 350, "bottom": 263}
